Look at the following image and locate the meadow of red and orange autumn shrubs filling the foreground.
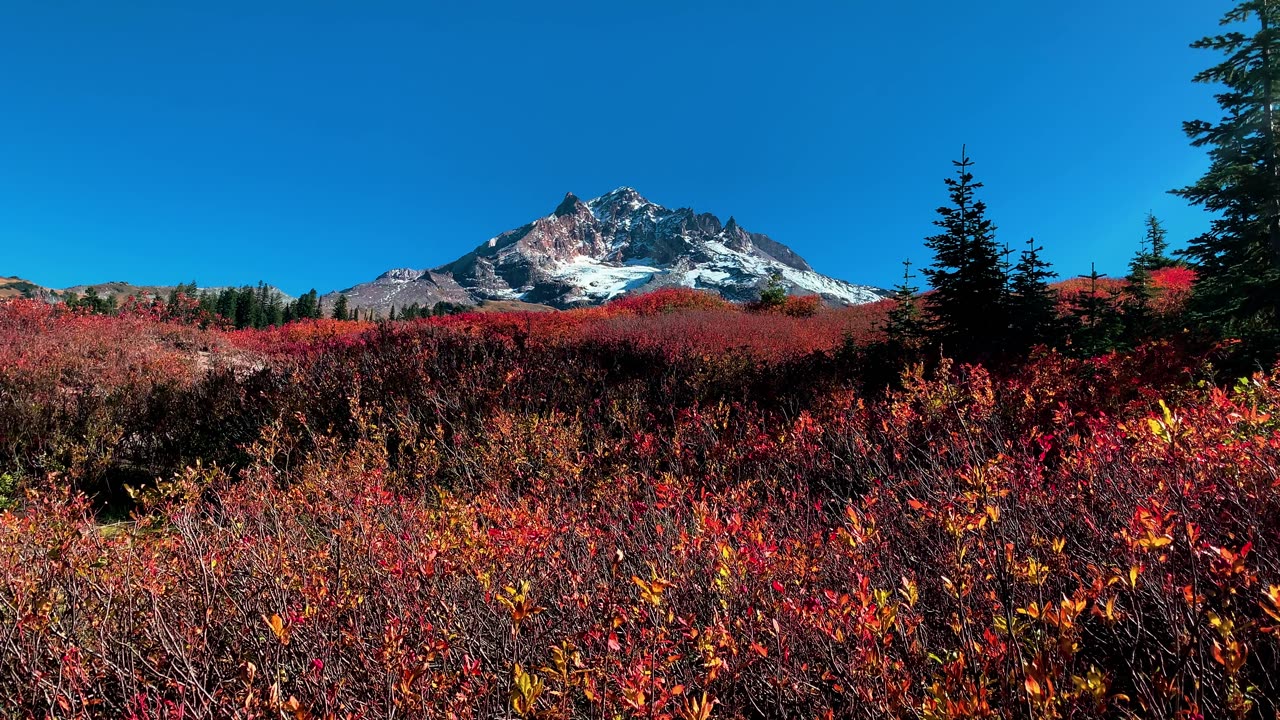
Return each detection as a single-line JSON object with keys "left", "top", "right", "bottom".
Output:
{"left": 0, "top": 291, "right": 1280, "bottom": 720}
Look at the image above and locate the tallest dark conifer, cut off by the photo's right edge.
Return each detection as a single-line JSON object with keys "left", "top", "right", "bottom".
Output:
{"left": 1175, "top": 0, "right": 1280, "bottom": 354}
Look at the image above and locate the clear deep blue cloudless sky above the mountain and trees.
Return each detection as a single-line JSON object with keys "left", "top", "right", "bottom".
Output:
{"left": 0, "top": 0, "right": 1230, "bottom": 293}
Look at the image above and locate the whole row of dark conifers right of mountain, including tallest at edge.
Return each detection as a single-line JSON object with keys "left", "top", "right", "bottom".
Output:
{"left": 884, "top": 0, "right": 1280, "bottom": 361}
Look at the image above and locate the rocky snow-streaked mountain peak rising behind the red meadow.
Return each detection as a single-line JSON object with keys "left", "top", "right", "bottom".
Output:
{"left": 326, "top": 187, "right": 886, "bottom": 311}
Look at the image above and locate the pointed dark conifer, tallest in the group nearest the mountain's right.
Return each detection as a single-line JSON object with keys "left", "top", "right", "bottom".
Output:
{"left": 924, "top": 150, "right": 1009, "bottom": 359}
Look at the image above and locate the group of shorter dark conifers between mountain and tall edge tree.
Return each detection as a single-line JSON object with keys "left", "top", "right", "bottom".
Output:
{"left": 884, "top": 149, "right": 1183, "bottom": 361}
